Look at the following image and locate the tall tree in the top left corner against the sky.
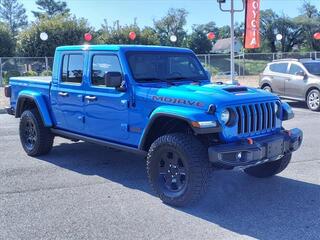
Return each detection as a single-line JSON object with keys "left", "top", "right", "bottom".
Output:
{"left": 0, "top": 0, "right": 28, "bottom": 37}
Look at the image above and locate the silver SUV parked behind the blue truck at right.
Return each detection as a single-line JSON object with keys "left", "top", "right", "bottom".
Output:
{"left": 259, "top": 59, "right": 320, "bottom": 111}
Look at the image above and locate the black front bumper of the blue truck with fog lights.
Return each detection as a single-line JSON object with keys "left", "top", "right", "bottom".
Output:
{"left": 208, "top": 128, "right": 303, "bottom": 167}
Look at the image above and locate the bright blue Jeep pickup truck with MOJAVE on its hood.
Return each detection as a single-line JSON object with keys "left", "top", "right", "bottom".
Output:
{"left": 5, "top": 45, "right": 302, "bottom": 206}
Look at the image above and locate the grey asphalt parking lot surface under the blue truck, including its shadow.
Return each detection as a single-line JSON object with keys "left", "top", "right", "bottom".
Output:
{"left": 0, "top": 102, "right": 320, "bottom": 240}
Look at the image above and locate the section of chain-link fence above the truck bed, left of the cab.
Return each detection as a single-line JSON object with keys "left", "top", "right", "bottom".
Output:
{"left": 0, "top": 57, "right": 53, "bottom": 87}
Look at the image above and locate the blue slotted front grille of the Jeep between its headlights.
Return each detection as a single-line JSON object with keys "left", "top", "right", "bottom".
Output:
{"left": 235, "top": 102, "right": 276, "bottom": 135}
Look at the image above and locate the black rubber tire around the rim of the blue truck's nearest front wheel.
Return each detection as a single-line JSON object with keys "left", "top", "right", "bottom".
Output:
{"left": 147, "top": 133, "right": 210, "bottom": 207}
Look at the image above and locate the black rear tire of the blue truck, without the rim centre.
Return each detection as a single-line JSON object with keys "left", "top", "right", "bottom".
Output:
{"left": 19, "top": 109, "right": 54, "bottom": 156}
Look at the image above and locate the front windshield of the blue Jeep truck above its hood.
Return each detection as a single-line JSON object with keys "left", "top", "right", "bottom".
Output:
{"left": 127, "top": 51, "right": 208, "bottom": 82}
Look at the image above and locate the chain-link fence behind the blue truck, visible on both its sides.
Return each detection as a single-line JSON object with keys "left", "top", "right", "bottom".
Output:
{"left": 0, "top": 52, "right": 320, "bottom": 86}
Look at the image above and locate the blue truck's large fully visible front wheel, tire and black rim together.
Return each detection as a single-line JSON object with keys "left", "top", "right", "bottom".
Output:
{"left": 147, "top": 133, "right": 210, "bottom": 206}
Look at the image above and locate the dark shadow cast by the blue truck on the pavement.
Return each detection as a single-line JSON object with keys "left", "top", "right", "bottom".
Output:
{"left": 40, "top": 142, "right": 320, "bottom": 239}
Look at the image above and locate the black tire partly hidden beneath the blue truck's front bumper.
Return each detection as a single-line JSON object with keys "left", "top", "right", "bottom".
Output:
{"left": 244, "top": 153, "right": 291, "bottom": 178}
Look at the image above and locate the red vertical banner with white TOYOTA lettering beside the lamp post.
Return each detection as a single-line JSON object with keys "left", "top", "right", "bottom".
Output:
{"left": 244, "top": 0, "right": 260, "bottom": 49}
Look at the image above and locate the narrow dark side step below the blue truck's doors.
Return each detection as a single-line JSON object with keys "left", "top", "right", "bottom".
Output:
{"left": 51, "top": 128, "right": 147, "bottom": 156}
